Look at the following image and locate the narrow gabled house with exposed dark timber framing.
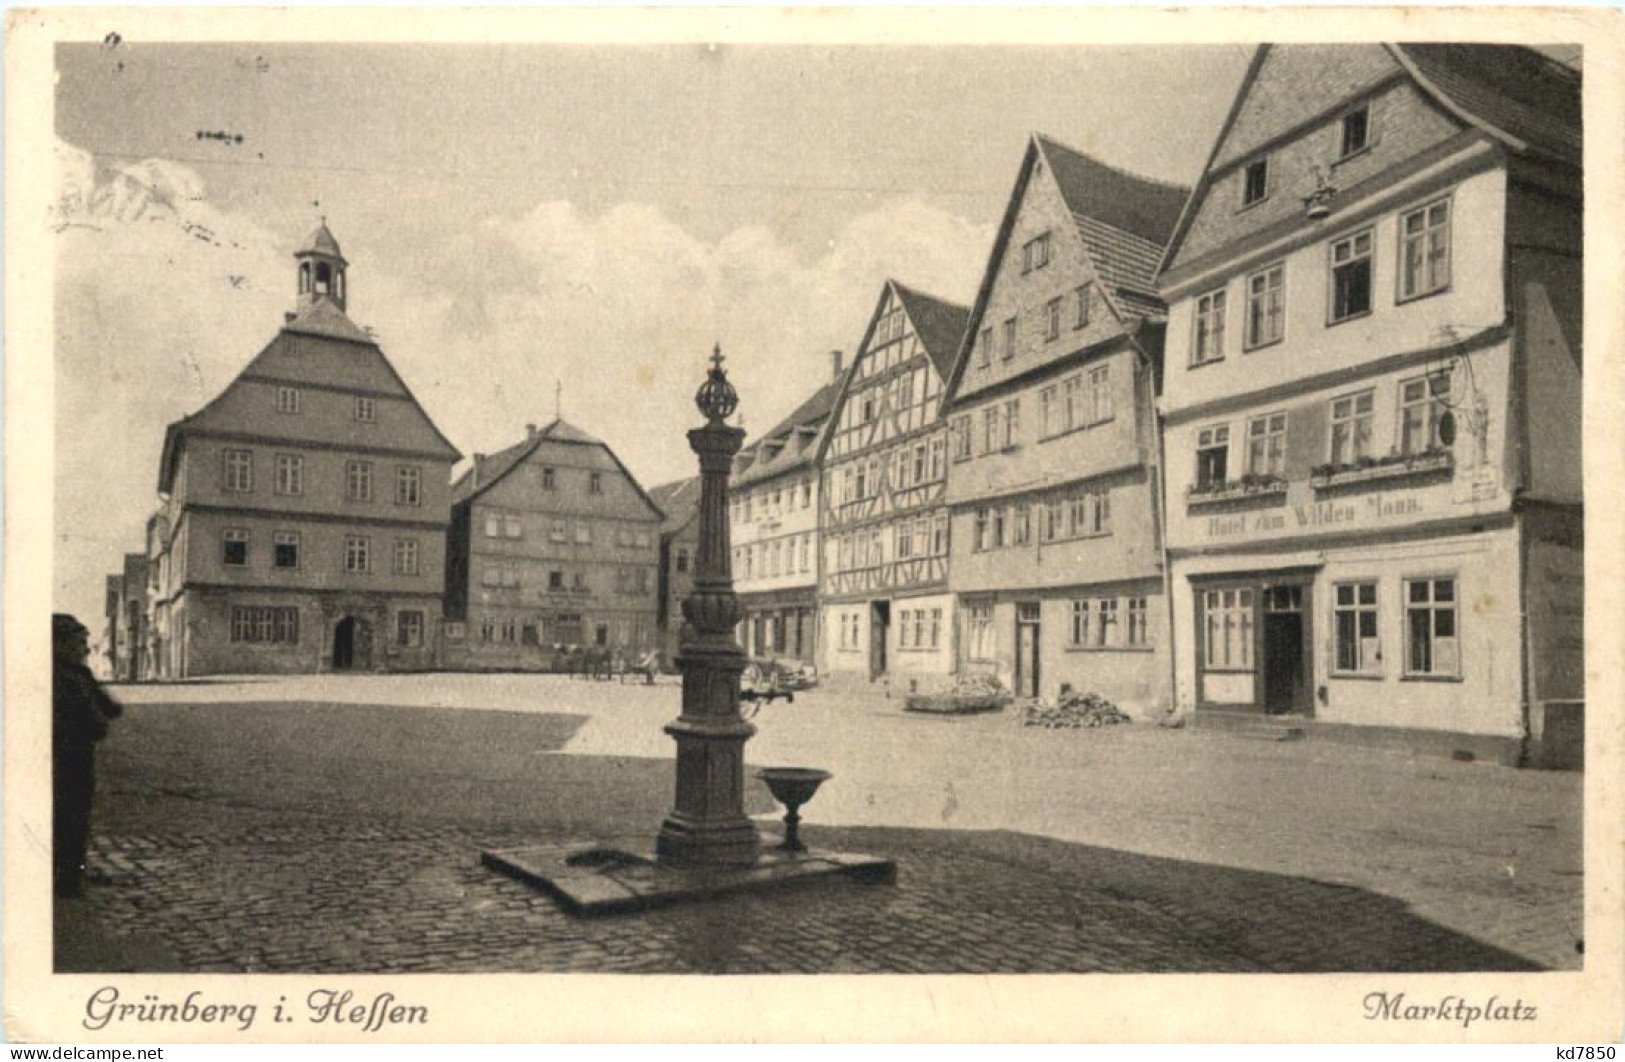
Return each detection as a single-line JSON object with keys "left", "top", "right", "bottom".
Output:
{"left": 819, "top": 281, "right": 967, "bottom": 689}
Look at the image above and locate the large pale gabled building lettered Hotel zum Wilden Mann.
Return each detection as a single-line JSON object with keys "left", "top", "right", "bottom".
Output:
{"left": 1160, "top": 44, "right": 1584, "bottom": 762}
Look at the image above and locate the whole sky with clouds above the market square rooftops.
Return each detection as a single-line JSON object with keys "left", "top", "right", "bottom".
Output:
{"left": 47, "top": 39, "right": 1250, "bottom": 627}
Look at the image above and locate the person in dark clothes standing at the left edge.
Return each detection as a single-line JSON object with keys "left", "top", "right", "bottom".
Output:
{"left": 50, "top": 612, "right": 124, "bottom": 896}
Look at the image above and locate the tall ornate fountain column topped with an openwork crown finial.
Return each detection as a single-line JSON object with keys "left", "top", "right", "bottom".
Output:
{"left": 655, "top": 346, "right": 762, "bottom": 869}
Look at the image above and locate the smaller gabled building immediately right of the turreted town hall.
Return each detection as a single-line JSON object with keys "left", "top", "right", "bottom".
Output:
{"left": 445, "top": 421, "right": 665, "bottom": 671}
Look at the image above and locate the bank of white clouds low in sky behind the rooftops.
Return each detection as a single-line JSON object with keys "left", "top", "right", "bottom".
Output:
{"left": 50, "top": 137, "right": 993, "bottom": 626}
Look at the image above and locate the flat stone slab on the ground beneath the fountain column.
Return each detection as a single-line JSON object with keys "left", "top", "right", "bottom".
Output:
{"left": 479, "top": 838, "right": 897, "bottom": 914}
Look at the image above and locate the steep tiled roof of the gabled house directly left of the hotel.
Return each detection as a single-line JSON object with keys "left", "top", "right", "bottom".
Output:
{"left": 944, "top": 133, "right": 1190, "bottom": 403}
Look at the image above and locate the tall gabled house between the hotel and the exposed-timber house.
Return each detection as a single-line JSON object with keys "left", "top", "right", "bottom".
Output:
{"left": 947, "top": 136, "right": 1188, "bottom": 710}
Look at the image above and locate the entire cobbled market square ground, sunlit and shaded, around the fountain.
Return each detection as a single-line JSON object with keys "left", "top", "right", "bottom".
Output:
{"left": 69, "top": 676, "right": 1583, "bottom": 973}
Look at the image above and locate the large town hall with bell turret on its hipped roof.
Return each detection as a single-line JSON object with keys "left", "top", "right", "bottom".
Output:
{"left": 148, "top": 224, "right": 458, "bottom": 679}
